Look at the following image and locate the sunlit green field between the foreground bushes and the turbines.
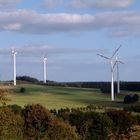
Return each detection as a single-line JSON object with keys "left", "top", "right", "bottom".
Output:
{"left": 3, "top": 84, "right": 133, "bottom": 109}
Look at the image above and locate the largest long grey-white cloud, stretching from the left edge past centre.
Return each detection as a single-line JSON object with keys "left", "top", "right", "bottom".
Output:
{"left": 0, "top": 10, "right": 94, "bottom": 34}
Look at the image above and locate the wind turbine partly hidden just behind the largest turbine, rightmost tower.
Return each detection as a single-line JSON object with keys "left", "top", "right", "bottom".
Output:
{"left": 116, "top": 57, "right": 124, "bottom": 93}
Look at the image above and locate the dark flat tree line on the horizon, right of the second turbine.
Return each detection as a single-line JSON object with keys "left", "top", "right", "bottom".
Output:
{"left": 47, "top": 81, "right": 140, "bottom": 93}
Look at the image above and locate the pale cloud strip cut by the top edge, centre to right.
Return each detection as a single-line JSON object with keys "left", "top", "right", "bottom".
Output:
{"left": 42, "top": 0, "right": 135, "bottom": 8}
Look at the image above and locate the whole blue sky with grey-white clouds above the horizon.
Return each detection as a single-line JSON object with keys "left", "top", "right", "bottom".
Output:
{"left": 0, "top": 0, "right": 140, "bottom": 82}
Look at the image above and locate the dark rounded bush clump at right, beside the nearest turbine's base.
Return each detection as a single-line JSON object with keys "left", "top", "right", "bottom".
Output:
{"left": 124, "top": 94, "right": 139, "bottom": 104}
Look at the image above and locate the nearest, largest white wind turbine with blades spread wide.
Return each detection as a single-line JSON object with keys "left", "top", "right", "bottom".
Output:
{"left": 97, "top": 45, "right": 121, "bottom": 101}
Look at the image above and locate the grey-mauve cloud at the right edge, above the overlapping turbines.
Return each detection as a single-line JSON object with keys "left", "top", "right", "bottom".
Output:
{"left": 96, "top": 12, "right": 140, "bottom": 36}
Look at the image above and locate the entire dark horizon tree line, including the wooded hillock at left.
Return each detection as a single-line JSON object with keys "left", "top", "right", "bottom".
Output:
{"left": 17, "top": 76, "right": 140, "bottom": 93}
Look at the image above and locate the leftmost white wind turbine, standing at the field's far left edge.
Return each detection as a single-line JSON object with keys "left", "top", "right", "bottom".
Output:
{"left": 12, "top": 48, "right": 17, "bottom": 86}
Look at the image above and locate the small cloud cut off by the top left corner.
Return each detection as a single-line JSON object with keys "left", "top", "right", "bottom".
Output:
{"left": 0, "top": 0, "right": 20, "bottom": 7}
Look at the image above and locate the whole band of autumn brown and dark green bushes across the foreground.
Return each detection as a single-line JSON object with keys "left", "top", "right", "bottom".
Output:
{"left": 0, "top": 104, "right": 140, "bottom": 140}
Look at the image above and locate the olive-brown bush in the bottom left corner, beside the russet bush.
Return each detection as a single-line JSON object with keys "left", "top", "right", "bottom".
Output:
{"left": 0, "top": 107, "right": 23, "bottom": 140}
